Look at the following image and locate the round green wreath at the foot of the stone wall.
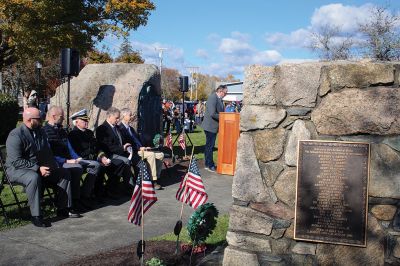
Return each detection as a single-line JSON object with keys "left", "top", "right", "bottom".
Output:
{"left": 187, "top": 203, "right": 218, "bottom": 246}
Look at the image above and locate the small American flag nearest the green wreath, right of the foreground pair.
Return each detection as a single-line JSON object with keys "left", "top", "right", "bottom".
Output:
{"left": 176, "top": 157, "right": 208, "bottom": 209}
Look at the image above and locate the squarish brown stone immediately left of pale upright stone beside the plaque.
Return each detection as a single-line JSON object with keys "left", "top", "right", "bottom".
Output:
{"left": 253, "top": 128, "right": 285, "bottom": 162}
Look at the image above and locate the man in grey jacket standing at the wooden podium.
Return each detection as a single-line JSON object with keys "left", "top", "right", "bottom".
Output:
{"left": 201, "top": 85, "right": 228, "bottom": 172}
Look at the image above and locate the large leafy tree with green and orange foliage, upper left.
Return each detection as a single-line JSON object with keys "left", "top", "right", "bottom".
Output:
{"left": 0, "top": 0, "right": 155, "bottom": 67}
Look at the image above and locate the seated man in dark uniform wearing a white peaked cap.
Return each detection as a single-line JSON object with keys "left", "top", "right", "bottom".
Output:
{"left": 68, "top": 109, "right": 111, "bottom": 202}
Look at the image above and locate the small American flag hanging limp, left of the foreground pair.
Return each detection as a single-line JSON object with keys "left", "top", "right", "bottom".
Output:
{"left": 128, "top": 161, "right": 157, "bottom": 225}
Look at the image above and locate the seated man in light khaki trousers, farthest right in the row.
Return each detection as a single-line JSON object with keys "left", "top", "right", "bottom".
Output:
{"left": 119, "top": 108, "right": 164, "bottom": 189}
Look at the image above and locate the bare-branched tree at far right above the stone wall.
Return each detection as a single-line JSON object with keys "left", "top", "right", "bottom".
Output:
{"left": 359, "top": 7, "right": 400, "bottom": 61}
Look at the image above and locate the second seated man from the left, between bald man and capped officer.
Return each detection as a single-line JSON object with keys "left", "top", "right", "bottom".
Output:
{"left": 43, "top": 106, "right": 91, "bottom": 211}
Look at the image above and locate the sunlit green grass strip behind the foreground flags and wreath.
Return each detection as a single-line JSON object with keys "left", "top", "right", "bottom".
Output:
{"left": 150, "top": 214, "right": 229, "bottom": 245}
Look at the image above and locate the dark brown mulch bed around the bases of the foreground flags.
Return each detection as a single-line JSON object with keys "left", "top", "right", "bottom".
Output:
{"left": 63, "top": 240, "right": 215, "bottom": 266}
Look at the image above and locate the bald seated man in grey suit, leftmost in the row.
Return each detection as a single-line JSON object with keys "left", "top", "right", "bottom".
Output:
{"left": 6, "top": 107, "right": 80, "bottom": 227}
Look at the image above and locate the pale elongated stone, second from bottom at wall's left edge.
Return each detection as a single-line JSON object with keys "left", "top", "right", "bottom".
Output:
{"left": 226, "top": 231, "right": 272, "bottom": 252}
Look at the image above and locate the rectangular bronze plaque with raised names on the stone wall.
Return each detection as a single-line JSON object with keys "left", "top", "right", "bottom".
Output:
{"left": 294, "top": 141, "right": 370, "bottom": 247}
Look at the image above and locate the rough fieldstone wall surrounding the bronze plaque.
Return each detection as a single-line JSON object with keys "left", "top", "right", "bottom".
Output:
{"left": 223, "top": 61, "right": 400, "bottom": 266}
